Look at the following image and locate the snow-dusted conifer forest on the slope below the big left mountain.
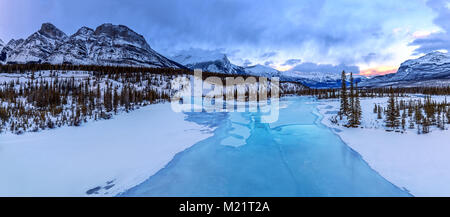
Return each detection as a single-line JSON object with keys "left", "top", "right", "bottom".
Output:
{"left": 0, "top": 71, "right": 170, "bottom": 134}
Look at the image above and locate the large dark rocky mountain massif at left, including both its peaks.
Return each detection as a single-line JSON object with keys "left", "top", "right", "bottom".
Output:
{"left": 2, "top": 23, "right": 183, "bottom": 68}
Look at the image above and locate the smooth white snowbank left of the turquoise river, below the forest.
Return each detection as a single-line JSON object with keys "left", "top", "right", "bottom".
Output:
{"left": 0, "top": 103, "right": 211, "bottom": 196}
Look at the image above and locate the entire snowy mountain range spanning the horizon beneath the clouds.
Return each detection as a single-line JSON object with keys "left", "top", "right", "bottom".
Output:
{"left": 0, "top": 23, "right": 450, "bottom": 88}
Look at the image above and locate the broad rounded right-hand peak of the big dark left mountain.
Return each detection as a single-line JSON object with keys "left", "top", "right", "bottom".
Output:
{"left": 48, "top": 24, "right": 184, "bottom": 68}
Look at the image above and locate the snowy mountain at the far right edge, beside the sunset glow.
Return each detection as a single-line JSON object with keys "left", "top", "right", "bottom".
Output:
{"left": 361, "top": 52, "right": 450, "bottom": 87}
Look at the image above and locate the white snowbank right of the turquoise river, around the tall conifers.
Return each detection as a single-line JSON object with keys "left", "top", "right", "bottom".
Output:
{"left": 318, "top": 97, "right": 450, "bottom": 196}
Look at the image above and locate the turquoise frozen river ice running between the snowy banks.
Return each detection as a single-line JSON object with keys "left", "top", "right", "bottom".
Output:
{"left": 119, "top": 97, "right": 410, "bottom": 197}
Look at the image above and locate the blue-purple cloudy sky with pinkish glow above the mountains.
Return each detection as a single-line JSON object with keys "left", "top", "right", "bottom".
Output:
{"left": 0, "top": 0, "right": 450, "bottom": 74}
